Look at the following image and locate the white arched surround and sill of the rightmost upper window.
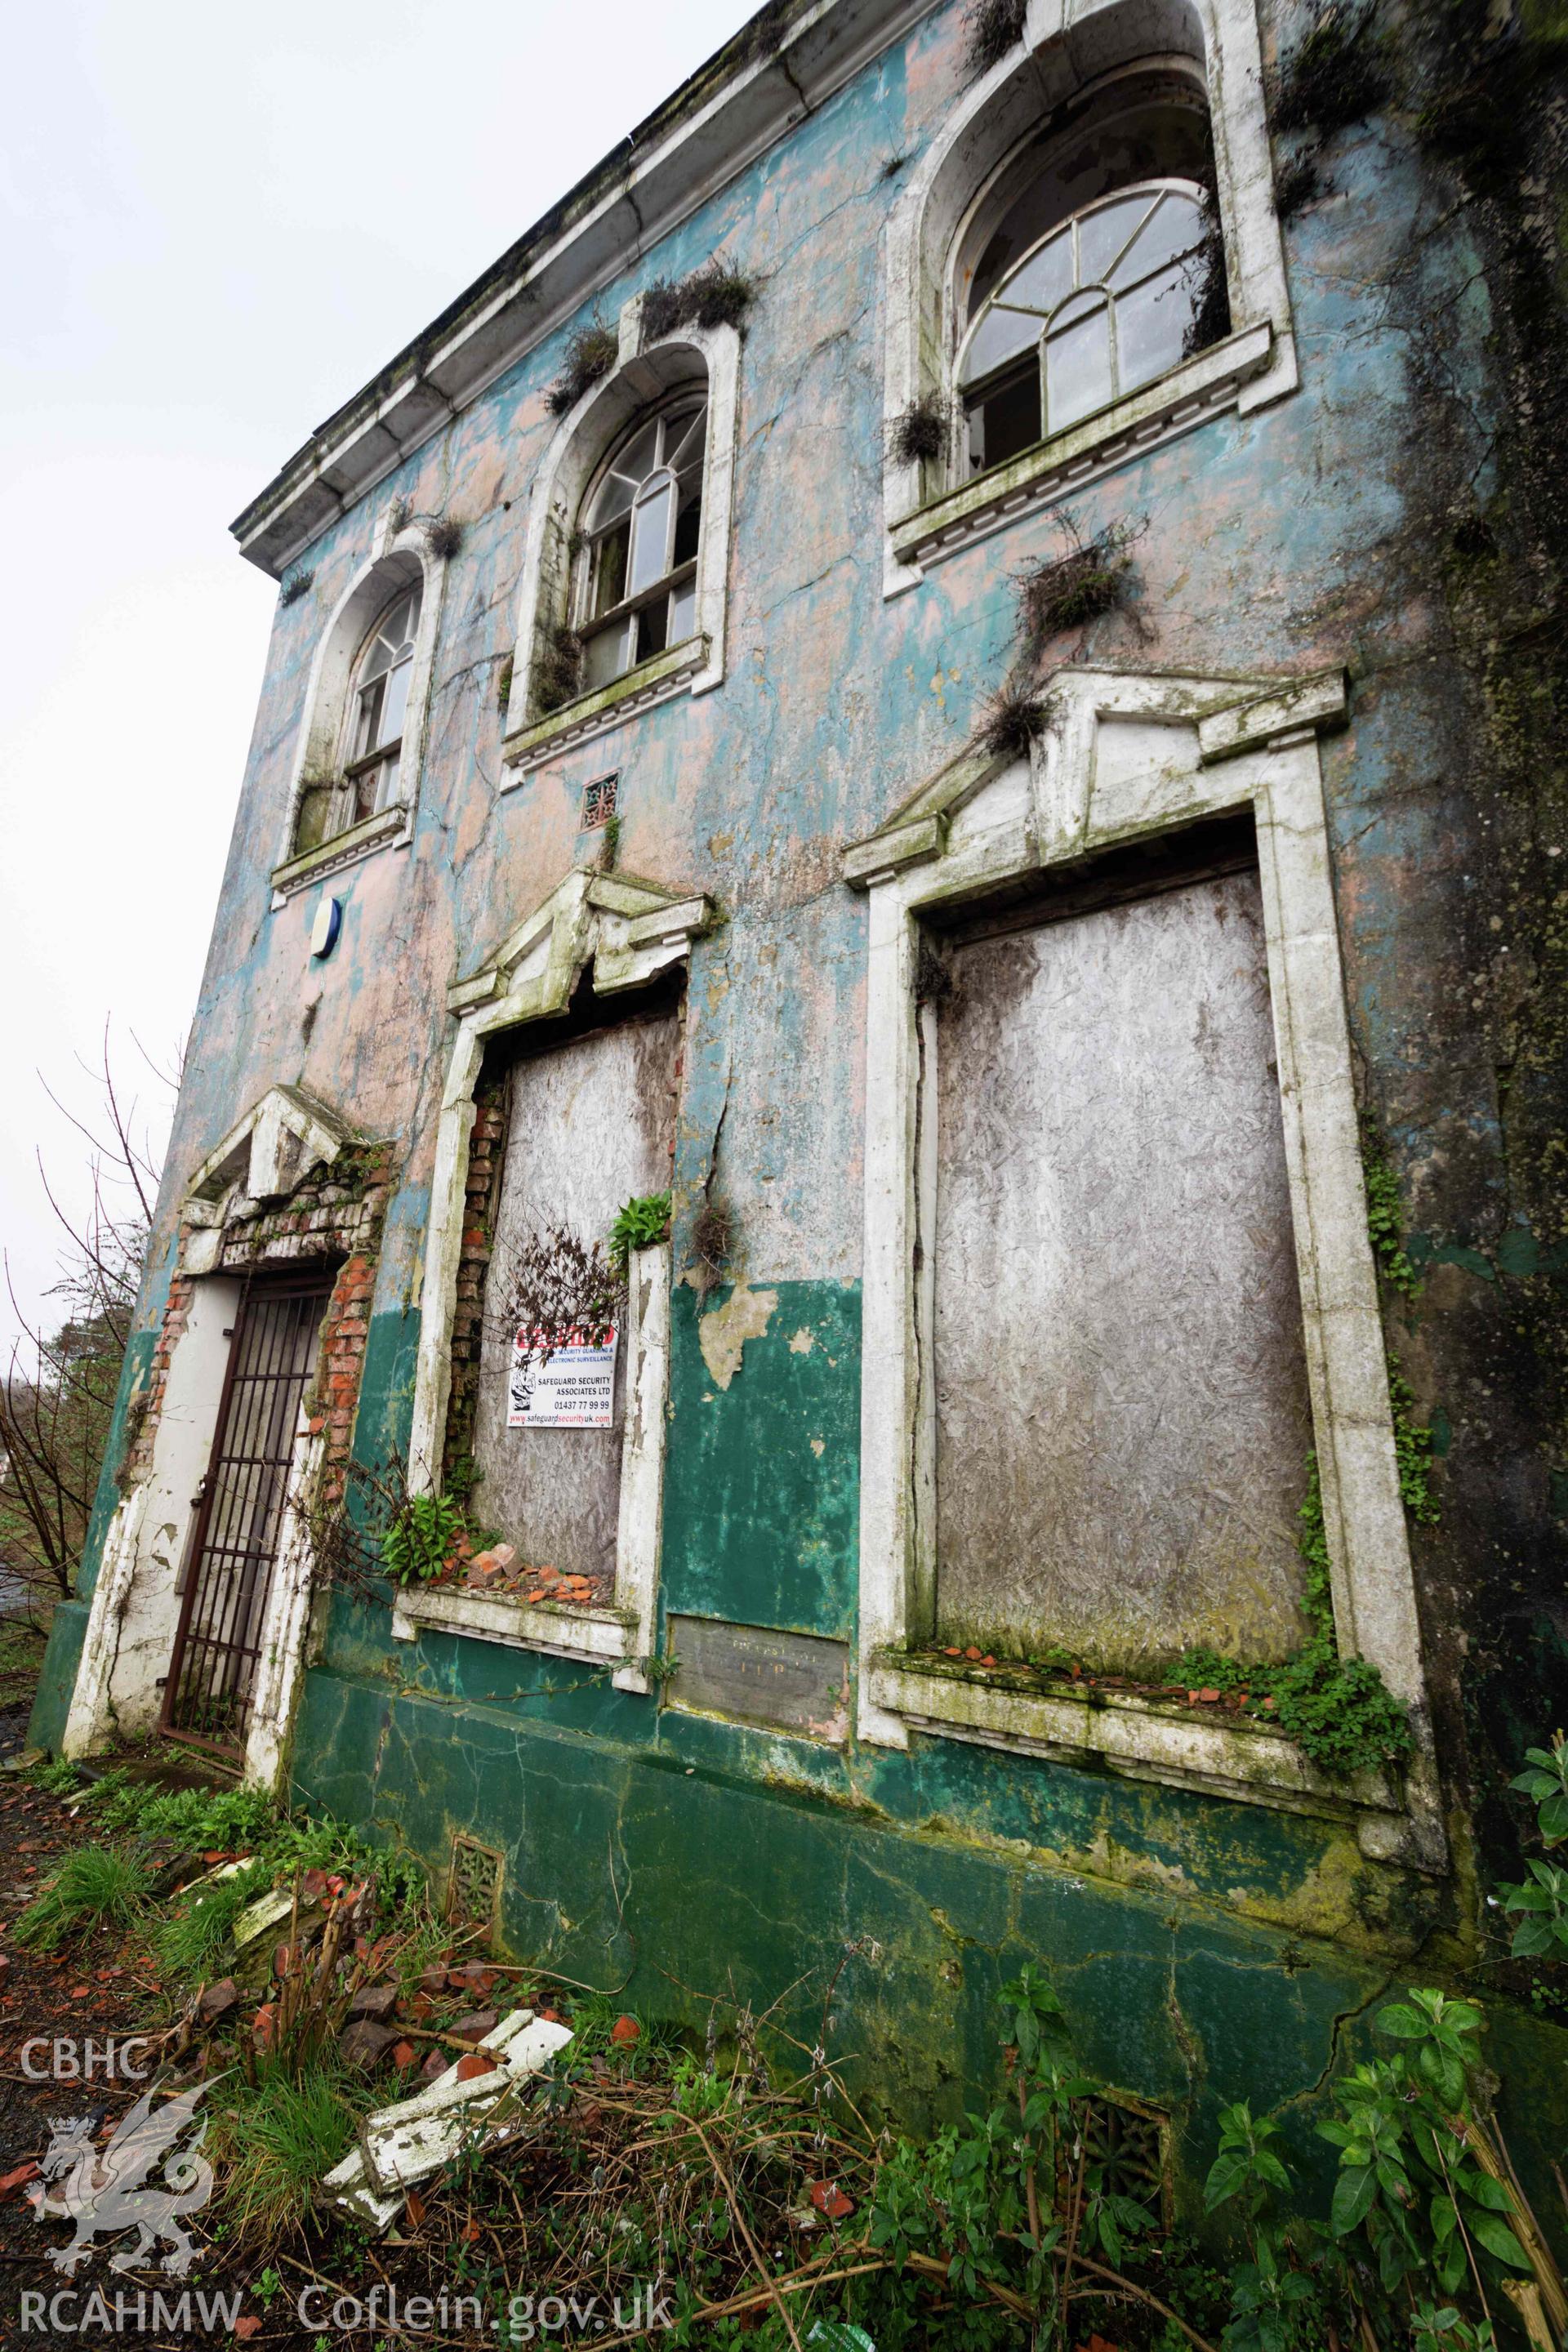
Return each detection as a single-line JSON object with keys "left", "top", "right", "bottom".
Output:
{"left": 881, "top": 0, "right": 1298, "bottom": 595}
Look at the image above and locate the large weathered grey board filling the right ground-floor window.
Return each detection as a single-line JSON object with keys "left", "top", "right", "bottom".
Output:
{"left": 926, "top": 868, "right": 1309, "bottom": 1670}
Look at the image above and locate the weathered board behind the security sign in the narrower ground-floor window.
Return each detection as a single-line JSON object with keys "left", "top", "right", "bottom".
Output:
{"left": 474, "top": 1011, "right": 679, "bottom": 1597}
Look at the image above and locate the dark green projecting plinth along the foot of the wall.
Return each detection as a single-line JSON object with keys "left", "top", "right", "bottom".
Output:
{"left": 285, "top": 1644, "right": 1568, "bottom": 2221}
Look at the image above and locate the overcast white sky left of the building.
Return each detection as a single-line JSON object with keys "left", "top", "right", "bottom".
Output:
{"left": 0, "top": 0, "right": 750, "bottom": 1331}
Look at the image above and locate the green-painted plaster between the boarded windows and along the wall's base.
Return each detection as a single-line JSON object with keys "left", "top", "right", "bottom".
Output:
{"left": 294, "top": 1284, "right": 1568, "bottom": 2221}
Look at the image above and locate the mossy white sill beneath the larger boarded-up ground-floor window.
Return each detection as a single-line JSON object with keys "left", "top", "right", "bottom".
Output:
{"left": 867, "top": 1649, "right": 1432, "bottom": 1870}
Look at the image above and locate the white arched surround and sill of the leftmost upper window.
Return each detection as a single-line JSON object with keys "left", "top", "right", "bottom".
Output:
{"left": 270, "top": 506, "right": 447, "bottom": 908}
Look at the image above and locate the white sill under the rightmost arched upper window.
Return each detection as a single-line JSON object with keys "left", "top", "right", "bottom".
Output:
{"left": 891, "top": 320, "right": 1274, "bottom": 588}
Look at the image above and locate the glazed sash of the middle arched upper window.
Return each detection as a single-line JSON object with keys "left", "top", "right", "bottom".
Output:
{"left": 576, "top": 395, "right": 707, "bottom": 692}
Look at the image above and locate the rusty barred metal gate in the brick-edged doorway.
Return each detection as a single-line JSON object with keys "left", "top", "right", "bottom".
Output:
{"left": 163, "top": 1277, "right": 329, "bottom": 1750}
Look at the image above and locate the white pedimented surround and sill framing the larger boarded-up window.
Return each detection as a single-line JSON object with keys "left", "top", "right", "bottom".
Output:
{"left": 844, "top": 670, "right": 1446, "bottom": 1872}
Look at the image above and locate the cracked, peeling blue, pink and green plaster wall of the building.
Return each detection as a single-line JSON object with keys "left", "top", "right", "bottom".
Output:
{"left": 38, "top": 5, "right": 1568, "bottom": 2173}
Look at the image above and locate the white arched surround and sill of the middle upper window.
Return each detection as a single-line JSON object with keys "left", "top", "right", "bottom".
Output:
{"left": 501, "top": 294, "right": 741, "bottom": 788}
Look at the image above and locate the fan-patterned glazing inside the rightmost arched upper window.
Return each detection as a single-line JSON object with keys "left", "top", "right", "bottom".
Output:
{"left": 959, "top": 179, "right": 1209, "bottom": 473}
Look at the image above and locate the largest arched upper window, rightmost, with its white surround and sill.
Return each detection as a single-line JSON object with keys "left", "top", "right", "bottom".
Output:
{"left": 881, "top": 0, "right": 1298, "bottom": 595}
